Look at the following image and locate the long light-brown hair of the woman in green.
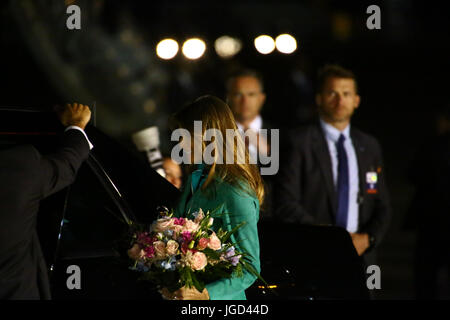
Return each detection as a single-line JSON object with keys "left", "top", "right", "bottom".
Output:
{"left": 170, "top": 95, "right": 264, "bottom": 206}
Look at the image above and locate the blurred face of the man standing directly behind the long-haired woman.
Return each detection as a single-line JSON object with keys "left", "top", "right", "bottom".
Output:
{"left": 228, "top": 77, "right": 266, "bottom": 122}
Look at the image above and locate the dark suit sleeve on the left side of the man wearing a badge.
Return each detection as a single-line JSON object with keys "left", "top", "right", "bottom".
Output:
{"left": 274, "top": 132, "right": 315, "bottom": 224}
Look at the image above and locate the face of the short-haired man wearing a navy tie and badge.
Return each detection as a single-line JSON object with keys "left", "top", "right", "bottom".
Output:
{"left": 316, "top": 77, "right": 360, "bottom": 122}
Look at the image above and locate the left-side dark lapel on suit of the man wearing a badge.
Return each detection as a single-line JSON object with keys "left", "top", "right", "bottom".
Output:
{"left": 312, "top": 124, "right": 337, "bottom": 218}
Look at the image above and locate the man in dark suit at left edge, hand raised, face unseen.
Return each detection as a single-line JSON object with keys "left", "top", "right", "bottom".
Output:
{"left": 0, "top": 104, "right": 92, "bottom": 300}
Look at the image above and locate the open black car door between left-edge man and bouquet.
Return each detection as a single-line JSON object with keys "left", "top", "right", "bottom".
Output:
{"left": 45, "top": 127, "right": 179, "bottom": 299}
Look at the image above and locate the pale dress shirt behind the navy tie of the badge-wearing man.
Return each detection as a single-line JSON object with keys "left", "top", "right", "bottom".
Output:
{"left": 320, "top": 119, "right": 359, "bottom": 232}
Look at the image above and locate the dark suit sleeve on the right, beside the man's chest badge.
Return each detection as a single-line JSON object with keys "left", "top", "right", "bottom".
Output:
{"left": 361, "top": 140, "right": 391, "bottom": 246}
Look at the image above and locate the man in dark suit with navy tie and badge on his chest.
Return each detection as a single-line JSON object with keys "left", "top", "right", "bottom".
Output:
{"left": 274, "top": 65, "right": 390, "bottom": 265}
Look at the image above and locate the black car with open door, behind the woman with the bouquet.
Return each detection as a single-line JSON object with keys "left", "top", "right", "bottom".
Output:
{"left": 0, "top": 107, "right": 369, "bottom": 300}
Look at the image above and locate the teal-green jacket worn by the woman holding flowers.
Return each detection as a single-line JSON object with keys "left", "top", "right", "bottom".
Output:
{"left": 174, "top": 175, "right": 261, "bottom": 300}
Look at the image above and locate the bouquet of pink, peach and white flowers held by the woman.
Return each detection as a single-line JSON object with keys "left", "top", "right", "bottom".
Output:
{"left": 128, "top": 208, "right": 264, "bottom": 292}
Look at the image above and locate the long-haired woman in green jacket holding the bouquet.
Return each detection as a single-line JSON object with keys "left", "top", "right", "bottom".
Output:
{"left": 162, "top": 96, "right": 264, "bottom": 300}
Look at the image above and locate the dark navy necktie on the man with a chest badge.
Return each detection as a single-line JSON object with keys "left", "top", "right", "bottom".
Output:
{"left": 336, "top": 134, "right": 349, "bottom": 228}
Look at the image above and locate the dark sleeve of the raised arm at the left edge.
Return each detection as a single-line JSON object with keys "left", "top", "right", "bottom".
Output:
{"left": 35, "top": 130, "right": 90, "bottom": 198}
